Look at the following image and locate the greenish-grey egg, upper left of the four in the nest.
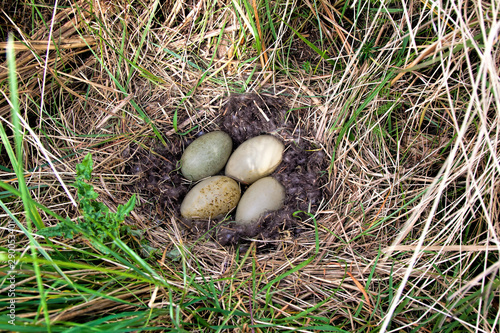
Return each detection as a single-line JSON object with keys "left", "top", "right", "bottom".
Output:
{"left": 181, "top": 131, "right": 233, "bottom": 181}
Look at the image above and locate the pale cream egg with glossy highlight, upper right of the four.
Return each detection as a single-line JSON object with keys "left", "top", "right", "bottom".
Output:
{"left": 225, "top": 135, "right": 285, "bottom": 184}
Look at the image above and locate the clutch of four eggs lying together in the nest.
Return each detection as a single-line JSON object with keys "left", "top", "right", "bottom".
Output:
{"left": 181, "top": 131, "right": 285, "bottom": 226}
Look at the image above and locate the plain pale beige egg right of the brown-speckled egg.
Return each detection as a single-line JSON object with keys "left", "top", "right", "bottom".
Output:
{"left": 235, "top": 177, "right": 285, "bottom": 226}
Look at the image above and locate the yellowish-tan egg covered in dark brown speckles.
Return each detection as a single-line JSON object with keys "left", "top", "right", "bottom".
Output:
{"left": 181, "top": 176, "right": 241, "bottom": 219}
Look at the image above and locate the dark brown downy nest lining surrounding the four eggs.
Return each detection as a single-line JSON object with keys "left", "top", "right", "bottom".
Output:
{"left": 124, "top": 94, "right": 328, "bottom": 245}
